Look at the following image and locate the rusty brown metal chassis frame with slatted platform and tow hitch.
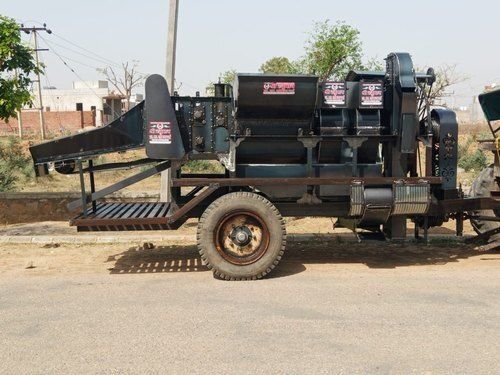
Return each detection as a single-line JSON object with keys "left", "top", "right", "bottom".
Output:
{"left": 68, "top": 160, "right": 500, "bottom": 235}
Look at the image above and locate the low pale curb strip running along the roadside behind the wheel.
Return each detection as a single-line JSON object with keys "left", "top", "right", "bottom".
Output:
{"left": 0, "top": 233, "right": 465, "bottom": 245}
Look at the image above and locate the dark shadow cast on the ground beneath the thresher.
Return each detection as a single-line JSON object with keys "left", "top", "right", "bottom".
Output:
{"left": 107, "top": 237, "right": 484, "bottom": 278}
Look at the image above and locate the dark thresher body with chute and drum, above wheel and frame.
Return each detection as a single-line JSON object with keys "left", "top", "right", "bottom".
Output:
{"left": 31, "top": 53, "right": 458, "bottom": 238}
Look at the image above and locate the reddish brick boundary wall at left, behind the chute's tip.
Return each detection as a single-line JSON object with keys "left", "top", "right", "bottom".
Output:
{"left": 0, "top": 111, "right": 93, "bottom": 136}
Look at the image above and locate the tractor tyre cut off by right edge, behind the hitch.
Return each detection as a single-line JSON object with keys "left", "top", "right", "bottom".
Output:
{"left": 469, "top": 166, "right": 500, "bottom": 240}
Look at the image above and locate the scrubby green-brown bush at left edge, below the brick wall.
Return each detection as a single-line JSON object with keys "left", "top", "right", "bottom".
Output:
{"left": 0, "top": 137, "right": 34, "bottom": 191}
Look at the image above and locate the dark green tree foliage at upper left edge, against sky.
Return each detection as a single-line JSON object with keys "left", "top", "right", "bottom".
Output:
{"left": 0, "top": 15, "right": 38, "bottom": 121}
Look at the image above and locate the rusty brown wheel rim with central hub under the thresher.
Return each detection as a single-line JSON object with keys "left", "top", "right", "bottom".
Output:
{"left": 214, "top": 211, "right": 269, "bottom": 266}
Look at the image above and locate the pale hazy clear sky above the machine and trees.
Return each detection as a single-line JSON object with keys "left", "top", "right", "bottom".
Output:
{"left": 0, "top": 0, "right": 500, "bottom": 104}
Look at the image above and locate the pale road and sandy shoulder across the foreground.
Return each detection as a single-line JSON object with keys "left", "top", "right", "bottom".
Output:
{"left": 0, "top": 244, "right": 500, "bottom": 374}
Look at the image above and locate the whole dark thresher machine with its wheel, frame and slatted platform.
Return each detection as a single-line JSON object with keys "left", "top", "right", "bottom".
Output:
{"left": 30, "top": 53, "right": 500, "bottom": 280}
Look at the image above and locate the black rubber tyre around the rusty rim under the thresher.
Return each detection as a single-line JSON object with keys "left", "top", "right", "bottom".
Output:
{"left": 196, "top": 192, "right": 286, "bottom": 281}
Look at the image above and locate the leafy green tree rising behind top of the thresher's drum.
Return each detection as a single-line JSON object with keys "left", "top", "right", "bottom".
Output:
{"left": 300, "top": 20, "right": 363, "bottom": 80}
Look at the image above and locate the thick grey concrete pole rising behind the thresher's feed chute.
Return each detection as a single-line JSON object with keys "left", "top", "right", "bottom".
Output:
{"left": 160, "top": 0, "right": 179, "bottom": 202}
